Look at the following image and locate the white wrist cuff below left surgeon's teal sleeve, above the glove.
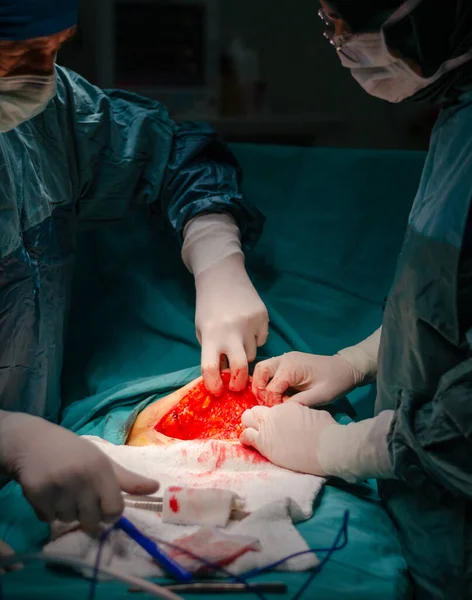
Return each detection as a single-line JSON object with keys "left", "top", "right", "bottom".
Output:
{"left": 182, "top": 213, "right": 243, "bottom": 278}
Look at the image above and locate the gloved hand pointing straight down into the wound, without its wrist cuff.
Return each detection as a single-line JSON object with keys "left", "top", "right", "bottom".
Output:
{"left": 195, "top": 254, "right": 269, "bottom": 394}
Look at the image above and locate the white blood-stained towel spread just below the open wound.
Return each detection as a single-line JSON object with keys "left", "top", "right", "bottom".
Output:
{"left": 44, "top": 437, "right": 324, "bottom": 577}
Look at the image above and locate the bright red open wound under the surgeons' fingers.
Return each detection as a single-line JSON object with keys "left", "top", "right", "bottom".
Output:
{"left": 154, "top": 373, "right": 259, "bottom": 440}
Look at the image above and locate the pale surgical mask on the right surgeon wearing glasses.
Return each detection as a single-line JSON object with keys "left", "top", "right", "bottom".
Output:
{"left": 322, "top": 0, "right": 472, "bottom": 103}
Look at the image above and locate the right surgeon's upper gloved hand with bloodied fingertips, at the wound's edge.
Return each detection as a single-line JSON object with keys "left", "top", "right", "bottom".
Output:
{"left": 252, "top": 352, "right": 365, "bottom": 406}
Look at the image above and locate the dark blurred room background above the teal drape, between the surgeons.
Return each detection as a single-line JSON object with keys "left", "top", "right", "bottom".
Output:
{"left": 58, "top": 0, "right": 435, "bottom": 149}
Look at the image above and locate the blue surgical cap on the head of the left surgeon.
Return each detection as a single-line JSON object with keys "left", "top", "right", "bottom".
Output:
{"left": 0, "top": 0, "right": 79, "bottom": 41}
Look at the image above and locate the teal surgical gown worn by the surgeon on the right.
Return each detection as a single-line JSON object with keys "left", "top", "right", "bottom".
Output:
{"left": 376, "top": 92, "right": 472, "bottom": 600}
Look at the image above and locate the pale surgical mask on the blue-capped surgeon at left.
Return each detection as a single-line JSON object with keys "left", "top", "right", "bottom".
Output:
{"left": 0, "top": 74, "right": 56, "bottom": 133}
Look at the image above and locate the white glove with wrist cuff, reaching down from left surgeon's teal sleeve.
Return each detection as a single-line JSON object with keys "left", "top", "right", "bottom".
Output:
{"left": 182, "top": 214, "right": 269, "bottom": 395}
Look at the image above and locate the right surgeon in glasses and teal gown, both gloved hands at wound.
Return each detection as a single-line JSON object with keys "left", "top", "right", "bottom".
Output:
{"left": 241, "top": 0, "right": 472, "bottom": 600}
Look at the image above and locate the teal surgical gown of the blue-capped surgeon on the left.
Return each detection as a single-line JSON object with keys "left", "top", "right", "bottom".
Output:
{"left": 0, "top": 67, "right": 262, "bottom": 421}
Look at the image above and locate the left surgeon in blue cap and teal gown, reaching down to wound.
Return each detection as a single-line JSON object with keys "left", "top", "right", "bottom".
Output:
{"left": 0, "top": 0, "right": 268, "bottom": 540}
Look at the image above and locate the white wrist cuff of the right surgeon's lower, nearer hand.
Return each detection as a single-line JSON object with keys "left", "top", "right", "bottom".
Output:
{"left": 318, "top": 410, "right": 395, "bottom": 483}
